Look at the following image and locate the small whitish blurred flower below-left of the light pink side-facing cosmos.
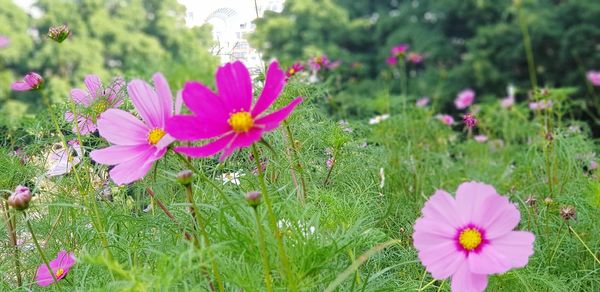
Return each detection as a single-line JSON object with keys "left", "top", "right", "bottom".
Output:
{"left": 46, "top": 140, "right": 83, "bottom": 176}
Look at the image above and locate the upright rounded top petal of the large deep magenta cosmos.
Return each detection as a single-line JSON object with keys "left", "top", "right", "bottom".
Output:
{"left": 216, "top": 61, "right": 252, "bottom": 112}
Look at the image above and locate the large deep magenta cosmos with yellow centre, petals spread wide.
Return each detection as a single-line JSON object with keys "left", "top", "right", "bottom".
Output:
{"left": 167, "top": 61, "right": 302, "bottom": 160}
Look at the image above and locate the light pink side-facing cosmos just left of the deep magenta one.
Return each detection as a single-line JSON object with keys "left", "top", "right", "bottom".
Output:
{"left": 90, "top": 73, "right": 181, "bottom": 185}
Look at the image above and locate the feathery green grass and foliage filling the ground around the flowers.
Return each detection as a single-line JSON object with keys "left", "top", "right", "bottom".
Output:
{"left": 0, "top": 76, "right": 600, "bottom": 291}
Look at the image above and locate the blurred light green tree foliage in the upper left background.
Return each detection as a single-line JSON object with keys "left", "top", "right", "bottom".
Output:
{"left": 0, "top": 0, "right": 218, "bottom": 123}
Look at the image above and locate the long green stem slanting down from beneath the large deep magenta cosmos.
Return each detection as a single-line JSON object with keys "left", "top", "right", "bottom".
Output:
{"left": 252, "top": 144, "right": 298, "bottom": 291}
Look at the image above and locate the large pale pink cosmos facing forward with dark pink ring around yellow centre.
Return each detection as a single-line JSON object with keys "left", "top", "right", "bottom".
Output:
{"left": 413, "top": 182, "right": 535, "bottom": 292}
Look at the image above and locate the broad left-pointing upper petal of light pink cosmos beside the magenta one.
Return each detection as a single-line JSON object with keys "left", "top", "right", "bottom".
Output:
{"left": 98, "top": 109, "right": 150, "bottom": 145}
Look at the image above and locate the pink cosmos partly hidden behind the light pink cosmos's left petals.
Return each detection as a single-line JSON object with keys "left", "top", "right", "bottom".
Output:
{"left": 65, "top": 75, "right": 125, "bottom": 135}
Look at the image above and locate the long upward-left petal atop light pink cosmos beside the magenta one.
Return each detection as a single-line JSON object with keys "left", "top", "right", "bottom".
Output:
{"left": 127, "top": 80, "right": 166, "bottom": 128}
